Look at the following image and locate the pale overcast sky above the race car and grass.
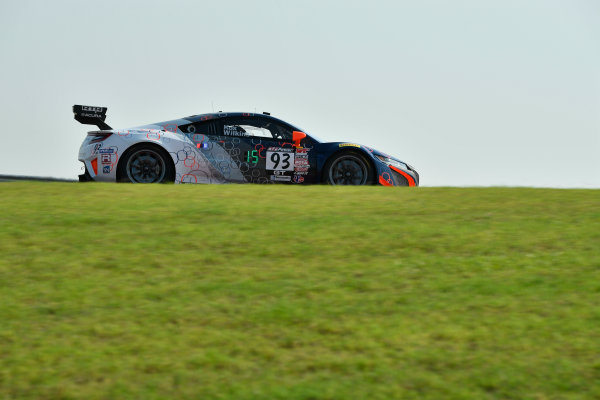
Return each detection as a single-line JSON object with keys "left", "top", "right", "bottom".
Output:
{"left": 0, "top": 0, "right": 600, "bottom": 188}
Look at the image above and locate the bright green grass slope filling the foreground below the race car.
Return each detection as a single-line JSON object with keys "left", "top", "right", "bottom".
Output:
{"left": 0, "top": 183, "right": 600, "bottom": 400}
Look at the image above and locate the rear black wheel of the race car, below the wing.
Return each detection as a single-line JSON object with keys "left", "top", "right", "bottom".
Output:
{"left": 117, "top": 143, "right": 175, "bottom": 183}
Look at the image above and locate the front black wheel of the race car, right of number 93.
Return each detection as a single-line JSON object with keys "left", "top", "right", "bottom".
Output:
{"left": 323, "top": 151, "right": 375, "bottom": 185}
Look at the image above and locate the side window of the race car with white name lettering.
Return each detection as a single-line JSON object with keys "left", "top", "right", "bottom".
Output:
{"left": 221, "top": 118, "right": 292, "bottom": 140}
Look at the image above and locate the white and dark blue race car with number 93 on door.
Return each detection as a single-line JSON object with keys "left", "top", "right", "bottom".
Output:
{"left": 73, "top": 105, "right": 419, "bottom": 186}
